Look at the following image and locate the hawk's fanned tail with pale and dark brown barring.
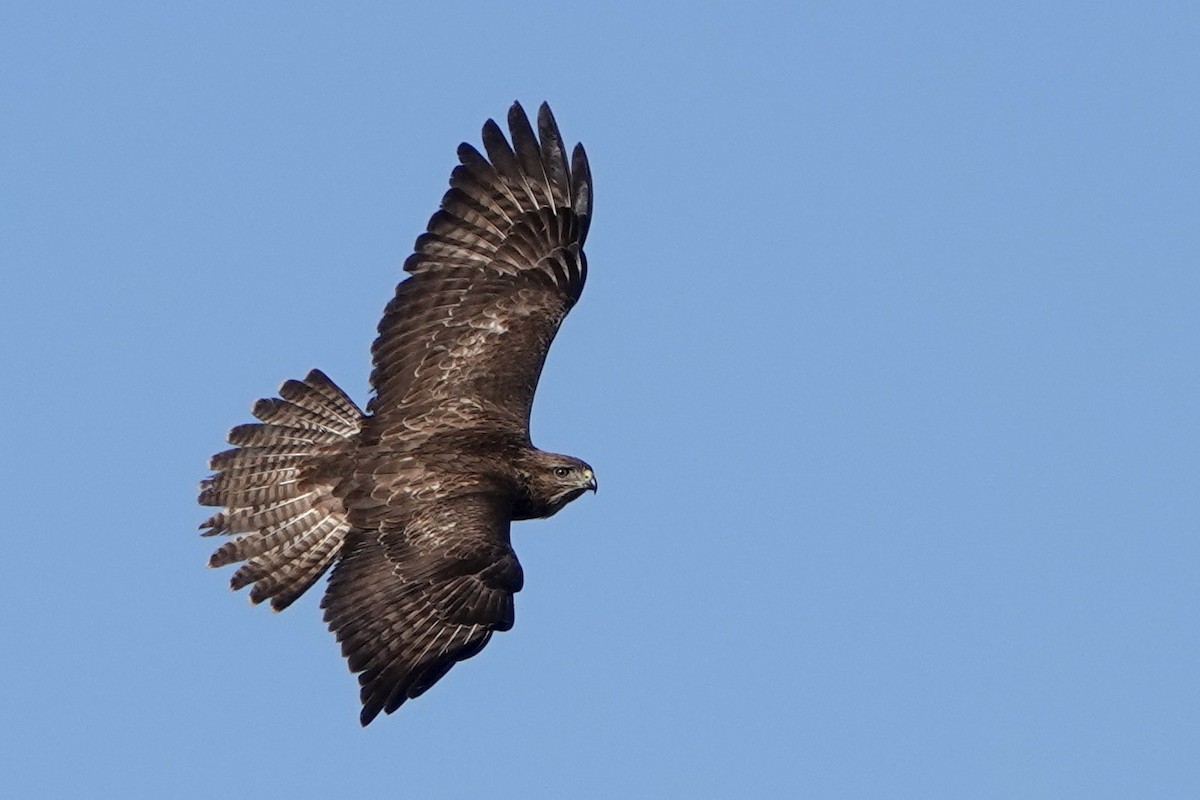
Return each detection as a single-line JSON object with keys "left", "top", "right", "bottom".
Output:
{"left": 199, "top": 369, "right": 362, "bottom": 610}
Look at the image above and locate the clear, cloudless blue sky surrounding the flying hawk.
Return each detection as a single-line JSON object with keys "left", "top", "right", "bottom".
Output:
{"left": 0, "top": 2, "right": 1200, "bottom": 799}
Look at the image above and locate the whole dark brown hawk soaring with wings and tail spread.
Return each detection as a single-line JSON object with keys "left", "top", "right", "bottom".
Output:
{"left": 199, "top": 103, "right": 596, "bottom": 726}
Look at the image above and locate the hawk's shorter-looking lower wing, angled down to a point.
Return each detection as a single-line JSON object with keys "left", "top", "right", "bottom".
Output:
{"left": 322, "top": 494, "right": 523, "bottom": 724}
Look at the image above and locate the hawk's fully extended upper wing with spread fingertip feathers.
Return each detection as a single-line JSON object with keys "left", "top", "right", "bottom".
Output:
{"left": 367, "top": 103, "right": 592, "bottom": 438}
